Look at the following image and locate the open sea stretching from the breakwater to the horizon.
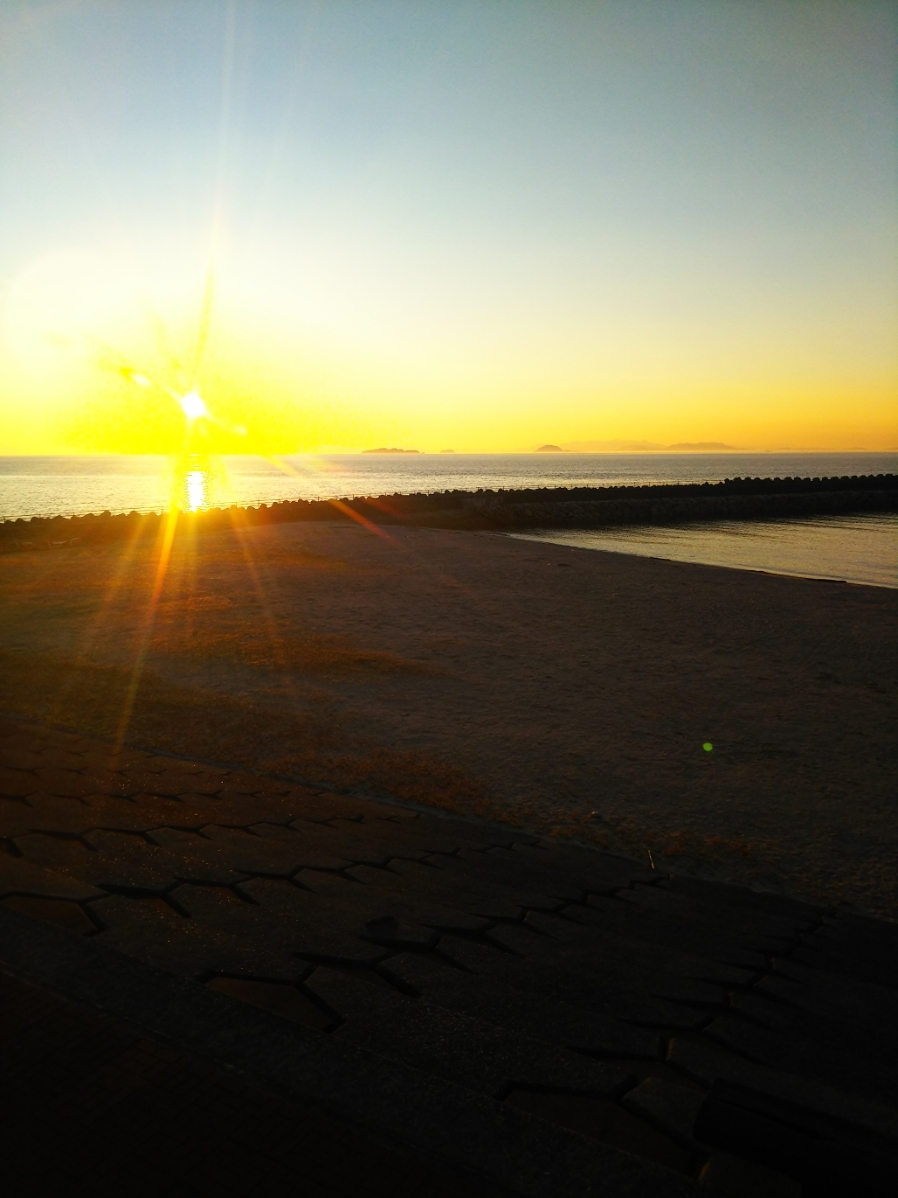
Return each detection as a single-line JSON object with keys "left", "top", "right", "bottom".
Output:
{"left": 0, "top": 453, "right": 898, "bottom": 520}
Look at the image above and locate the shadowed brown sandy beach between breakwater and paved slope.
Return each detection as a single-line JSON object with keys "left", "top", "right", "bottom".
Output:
{"left": 0, "top": 525, "right": 898, "bottom": 919}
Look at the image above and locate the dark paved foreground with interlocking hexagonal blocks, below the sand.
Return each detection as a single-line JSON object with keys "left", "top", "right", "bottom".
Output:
{"left": 0, "top": 721, "right": 898, "bottom": 1198}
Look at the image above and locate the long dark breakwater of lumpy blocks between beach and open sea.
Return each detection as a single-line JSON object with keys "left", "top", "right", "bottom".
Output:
{"left": 0, "top": 474, "right": 898, "bottom": 550}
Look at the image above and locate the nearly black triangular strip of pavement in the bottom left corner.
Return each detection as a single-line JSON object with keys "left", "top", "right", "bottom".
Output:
{"left": 0, "top": 975, "right": 498, "bottom": 1198}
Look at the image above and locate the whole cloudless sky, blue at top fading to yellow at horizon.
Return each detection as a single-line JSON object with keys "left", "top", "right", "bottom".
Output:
{"left": 0, "top": 0, "right": 898, "bottom": 453}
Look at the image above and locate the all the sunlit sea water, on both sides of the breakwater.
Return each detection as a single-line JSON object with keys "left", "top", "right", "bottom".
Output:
{"left": 0, "top": 453, "right": 898, "bottom": 587}
